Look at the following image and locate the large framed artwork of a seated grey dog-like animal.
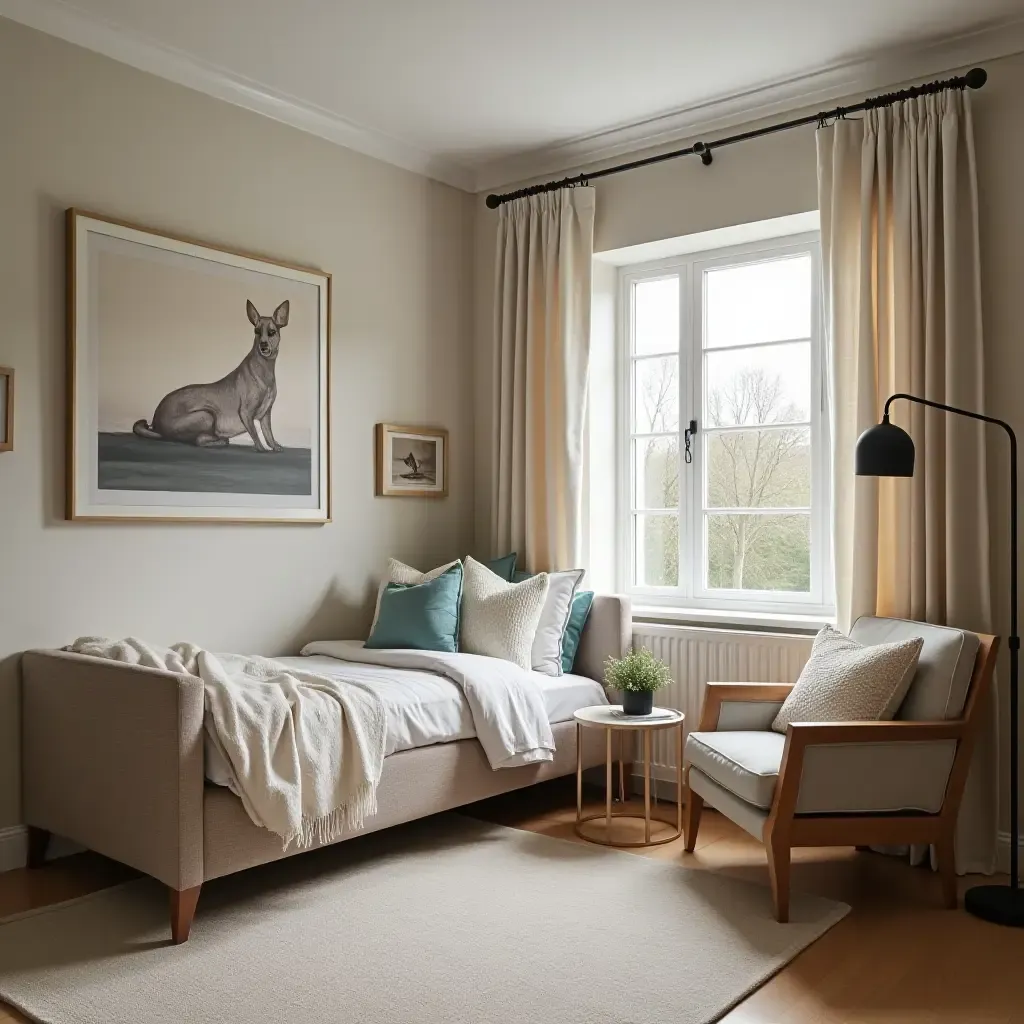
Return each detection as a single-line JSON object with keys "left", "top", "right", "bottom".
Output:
{"left": 67, "top": 210, "right": 331, "bottom": 523}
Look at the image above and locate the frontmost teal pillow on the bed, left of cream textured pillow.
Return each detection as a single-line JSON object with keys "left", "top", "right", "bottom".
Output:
{"left": 366, "top": 565, "right": 462, "bottom": 653}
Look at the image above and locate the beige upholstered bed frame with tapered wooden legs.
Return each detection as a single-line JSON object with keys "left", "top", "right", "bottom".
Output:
{"left": 22, "top": 595, "right": 632, "bottom": 942}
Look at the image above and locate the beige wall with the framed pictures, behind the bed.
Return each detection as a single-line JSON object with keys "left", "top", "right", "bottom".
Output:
{"left": 0, "top": 19, "right": 473, "bottom": 827}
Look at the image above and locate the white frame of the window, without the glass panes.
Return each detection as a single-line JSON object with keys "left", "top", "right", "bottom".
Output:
{"left": 615, "top": 231, "right": 835, "bottom": 617}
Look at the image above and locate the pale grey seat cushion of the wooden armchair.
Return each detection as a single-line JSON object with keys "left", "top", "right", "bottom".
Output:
{"left": 686, "top": 731, "right": 785, "bottom": 810}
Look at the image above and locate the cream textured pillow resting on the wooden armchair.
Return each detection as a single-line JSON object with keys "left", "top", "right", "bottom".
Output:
{"left": 771, "top": 626, "right": 925, "bottom": 732}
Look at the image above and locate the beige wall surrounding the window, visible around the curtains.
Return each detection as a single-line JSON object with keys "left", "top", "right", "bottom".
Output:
{"left": 475, "top": 54, "right": 1024, "bottom": 828}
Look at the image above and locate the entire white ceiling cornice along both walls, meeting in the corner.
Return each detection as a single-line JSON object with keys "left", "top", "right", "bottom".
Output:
{"left": 8, "top": 0, "right": 1024, "bottom": 191}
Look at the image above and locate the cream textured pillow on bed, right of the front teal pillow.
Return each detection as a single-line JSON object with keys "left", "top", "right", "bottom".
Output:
{"left": 459, "top": 558, "right": 548, "bottom": 670}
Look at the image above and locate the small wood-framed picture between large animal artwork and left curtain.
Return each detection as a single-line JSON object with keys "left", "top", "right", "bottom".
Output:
{"left": 374, "top": 423, "right": 449, "bottom": 498}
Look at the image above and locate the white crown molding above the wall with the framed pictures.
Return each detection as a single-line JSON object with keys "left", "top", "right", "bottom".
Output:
{"left": 0, "top": 0, "right": 475, "bottom": 191}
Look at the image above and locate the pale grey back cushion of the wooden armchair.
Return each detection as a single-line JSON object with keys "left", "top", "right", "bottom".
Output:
{"left": 850, "top": 615, "right": 981, "bottom": 722}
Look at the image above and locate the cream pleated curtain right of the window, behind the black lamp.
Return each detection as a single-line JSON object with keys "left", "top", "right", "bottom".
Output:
{"left": 817, "top": 91, "right": 1002, "bottom": 872}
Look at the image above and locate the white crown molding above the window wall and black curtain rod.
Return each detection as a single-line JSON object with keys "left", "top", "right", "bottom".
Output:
{"left": 476, "top": 18, "right": 1024, "bottom": 193}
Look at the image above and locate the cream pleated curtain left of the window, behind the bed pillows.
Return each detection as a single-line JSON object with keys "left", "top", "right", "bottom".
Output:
{"left": 492, "top": 187, "right": 594, "bottom": 572}
